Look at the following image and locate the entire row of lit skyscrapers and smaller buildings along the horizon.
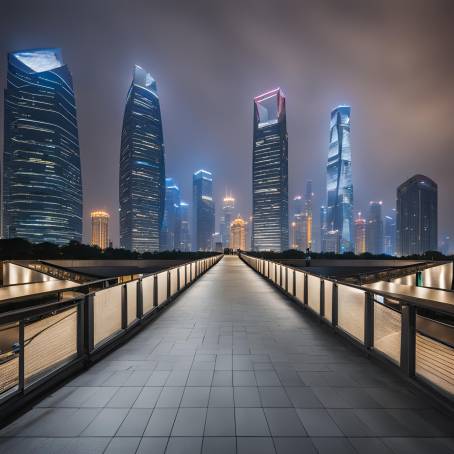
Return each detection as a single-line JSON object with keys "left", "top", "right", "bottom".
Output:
{"left": 2, "top": 49, "right": 444, "bottom": 255}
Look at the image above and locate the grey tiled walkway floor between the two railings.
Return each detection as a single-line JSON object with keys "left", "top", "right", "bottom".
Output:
{"left": 0, "top": 257, "right": 454, "bottom": 454}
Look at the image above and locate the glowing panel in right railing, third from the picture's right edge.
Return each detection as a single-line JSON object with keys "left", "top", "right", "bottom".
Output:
{"left": 337, "top": 284, "right": 365, "bottom": 343}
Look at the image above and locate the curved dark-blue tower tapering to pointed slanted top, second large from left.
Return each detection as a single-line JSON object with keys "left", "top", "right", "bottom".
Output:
{"left": 120, "top": 66, "right": 165, "bottom": 252}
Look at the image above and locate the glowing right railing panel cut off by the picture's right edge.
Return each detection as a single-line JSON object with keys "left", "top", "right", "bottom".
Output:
{"left": 416, "top": 324, "right": 454, "bottom": 396}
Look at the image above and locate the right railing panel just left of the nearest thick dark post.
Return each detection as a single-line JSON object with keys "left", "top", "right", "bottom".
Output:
{"left": 374, "top": 302, "right": 402, "bottom": 364}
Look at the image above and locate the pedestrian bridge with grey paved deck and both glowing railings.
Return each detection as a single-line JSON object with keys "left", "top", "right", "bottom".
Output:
{"left": 0, "top": 256, "right": 454, "bottom": 454}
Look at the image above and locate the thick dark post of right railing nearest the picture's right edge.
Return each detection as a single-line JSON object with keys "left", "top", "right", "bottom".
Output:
{"left": 400, "top": 304, "right": 416, "bottom": 377}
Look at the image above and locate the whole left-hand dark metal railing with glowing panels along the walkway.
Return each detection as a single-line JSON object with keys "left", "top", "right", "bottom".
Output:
{"left": 0, "top": 255, "right": 222, "bottom": 423}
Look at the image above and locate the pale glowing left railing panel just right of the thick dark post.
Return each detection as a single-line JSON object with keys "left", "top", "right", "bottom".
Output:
{"left": 93, "top": 285, "right": 122, "bottom": 347}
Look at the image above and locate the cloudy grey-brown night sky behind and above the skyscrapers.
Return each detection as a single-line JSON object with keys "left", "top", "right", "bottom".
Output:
{"left": 0, "top": 0, "right": 454, "bottom": 245}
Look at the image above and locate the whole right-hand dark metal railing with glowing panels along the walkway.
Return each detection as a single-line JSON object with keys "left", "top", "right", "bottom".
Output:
{"left": 240, "top": 254, "right": 454, "bottom": 403}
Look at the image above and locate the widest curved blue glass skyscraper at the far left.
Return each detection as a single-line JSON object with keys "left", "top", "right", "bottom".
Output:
{"left": 2, "top": 49, "right": 82, "bottom": 245}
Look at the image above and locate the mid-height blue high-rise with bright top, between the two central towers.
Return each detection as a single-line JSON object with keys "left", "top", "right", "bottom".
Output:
{"left": 192, "top": 170, "right": 215, "bottom": 251}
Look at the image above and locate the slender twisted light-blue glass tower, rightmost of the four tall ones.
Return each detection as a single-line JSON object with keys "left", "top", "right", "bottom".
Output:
{"left": 326, "top": 106, "right": 354, "bottom": 253}
